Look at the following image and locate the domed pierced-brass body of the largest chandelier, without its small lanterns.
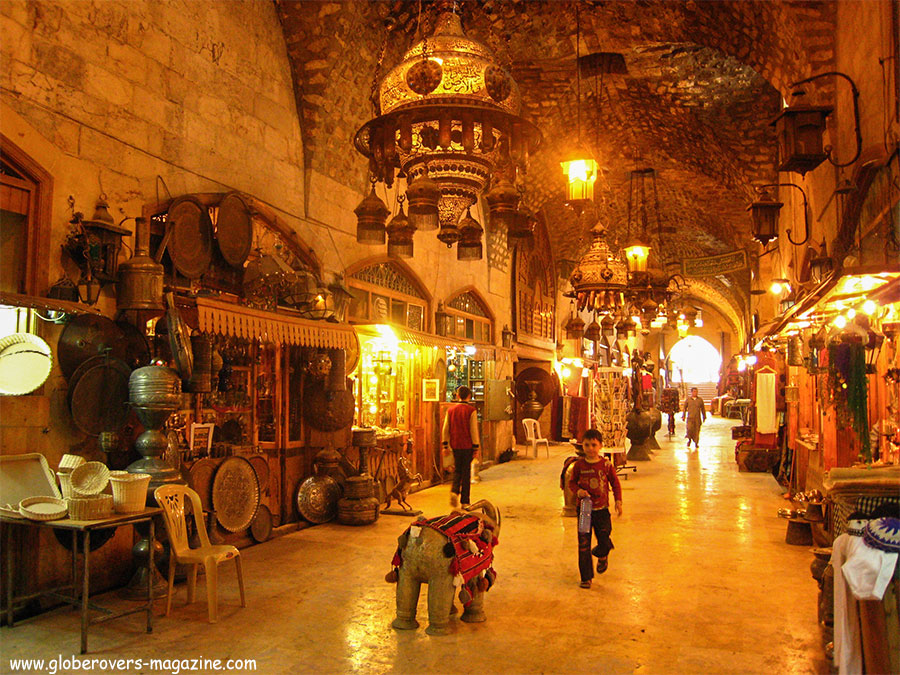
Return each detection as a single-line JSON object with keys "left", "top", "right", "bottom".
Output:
{"left": 354, "top": 11, "right": 541, "bottom": 251}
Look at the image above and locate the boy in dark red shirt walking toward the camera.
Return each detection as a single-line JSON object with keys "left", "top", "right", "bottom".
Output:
{"left": 569, "top": 429, "right": 622, "bottom": 588}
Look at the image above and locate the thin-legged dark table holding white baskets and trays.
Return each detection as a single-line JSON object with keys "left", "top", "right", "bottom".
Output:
{"left": 0, "top": 507, "right": 162, "bottom": 654}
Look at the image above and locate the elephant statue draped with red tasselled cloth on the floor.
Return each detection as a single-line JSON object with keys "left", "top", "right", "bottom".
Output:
{"left": 386, "top": 500, "right": 500, "bottom": 635}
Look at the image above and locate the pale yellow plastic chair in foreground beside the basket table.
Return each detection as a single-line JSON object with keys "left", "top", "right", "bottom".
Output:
{"left": 153, "top": 485, "right": 247, "bottom": 623}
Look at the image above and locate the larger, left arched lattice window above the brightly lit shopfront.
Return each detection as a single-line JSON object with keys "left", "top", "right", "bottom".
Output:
{"left": 347, "top": 262, "right": 428, "bottom": 331}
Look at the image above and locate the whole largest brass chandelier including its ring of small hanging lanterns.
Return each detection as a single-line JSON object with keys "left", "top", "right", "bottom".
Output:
{"left": 354, "top": 11, "right": 541, "bottom": 260}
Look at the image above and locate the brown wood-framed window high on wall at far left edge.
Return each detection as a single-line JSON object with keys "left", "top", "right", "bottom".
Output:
{"left": 0, "top": 136, "right": 52, "bottom": 295}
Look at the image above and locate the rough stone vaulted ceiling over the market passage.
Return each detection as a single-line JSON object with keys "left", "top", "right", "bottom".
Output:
{"left": 277, "top": 0, "right": 834, "bottom": 328}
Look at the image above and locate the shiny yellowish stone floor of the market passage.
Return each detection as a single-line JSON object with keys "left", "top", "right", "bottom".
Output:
{"left": 0, "top": 418, "right": 829, "bottom": 674}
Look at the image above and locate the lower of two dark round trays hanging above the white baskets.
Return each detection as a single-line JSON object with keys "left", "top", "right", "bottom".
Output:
{"left": 66, "top": 356, "right": 131, "bottom": 436}
